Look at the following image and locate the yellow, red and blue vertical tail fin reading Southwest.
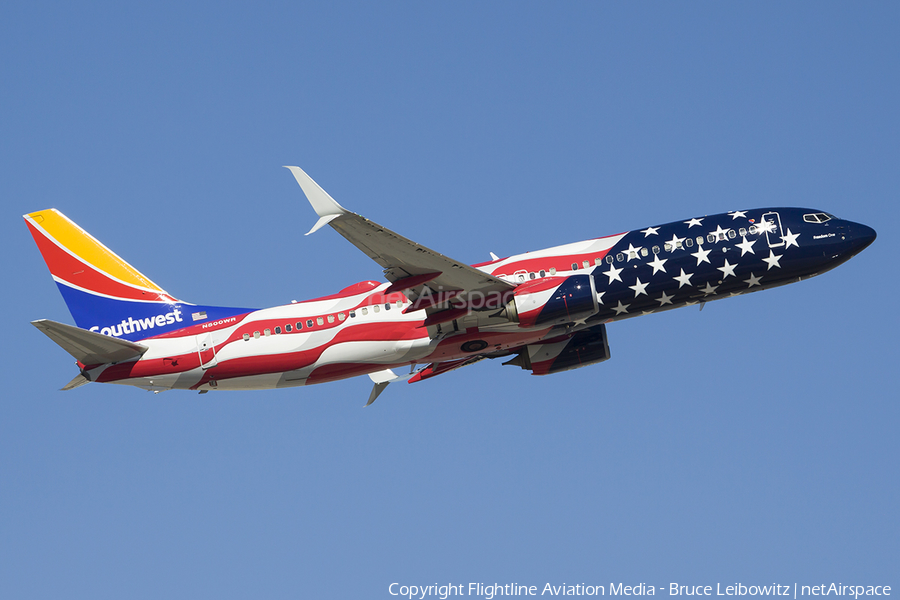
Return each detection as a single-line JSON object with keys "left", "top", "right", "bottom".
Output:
{"left": 24, "top": 208, "right": 250, "bottom": 341}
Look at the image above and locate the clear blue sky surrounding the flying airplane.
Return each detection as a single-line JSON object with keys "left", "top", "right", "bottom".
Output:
{"left": 0, "top": 2, "right": 900, "bottom": 599}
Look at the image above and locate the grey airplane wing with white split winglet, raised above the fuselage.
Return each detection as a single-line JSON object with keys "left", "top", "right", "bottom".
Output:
{"left": 285, "top": 167, "right": 515, "bottom": 308}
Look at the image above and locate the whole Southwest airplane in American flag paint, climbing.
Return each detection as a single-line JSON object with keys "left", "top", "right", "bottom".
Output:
{"left": 24, "top": 167, "right": 876, "bottom": 406}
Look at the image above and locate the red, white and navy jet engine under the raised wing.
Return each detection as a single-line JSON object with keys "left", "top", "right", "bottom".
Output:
{"left": 505, "top": 274, "right": 600, "bottom": 327}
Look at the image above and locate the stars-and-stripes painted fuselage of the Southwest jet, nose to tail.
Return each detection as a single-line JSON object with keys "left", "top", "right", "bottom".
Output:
{"left": 74, "top": 208, "right": 875, "bottom": 391}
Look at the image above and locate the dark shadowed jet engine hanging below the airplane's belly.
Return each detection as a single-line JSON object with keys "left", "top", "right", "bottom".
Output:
{"left": 503, "top": 325, "right": 610, "bottom": 375}
